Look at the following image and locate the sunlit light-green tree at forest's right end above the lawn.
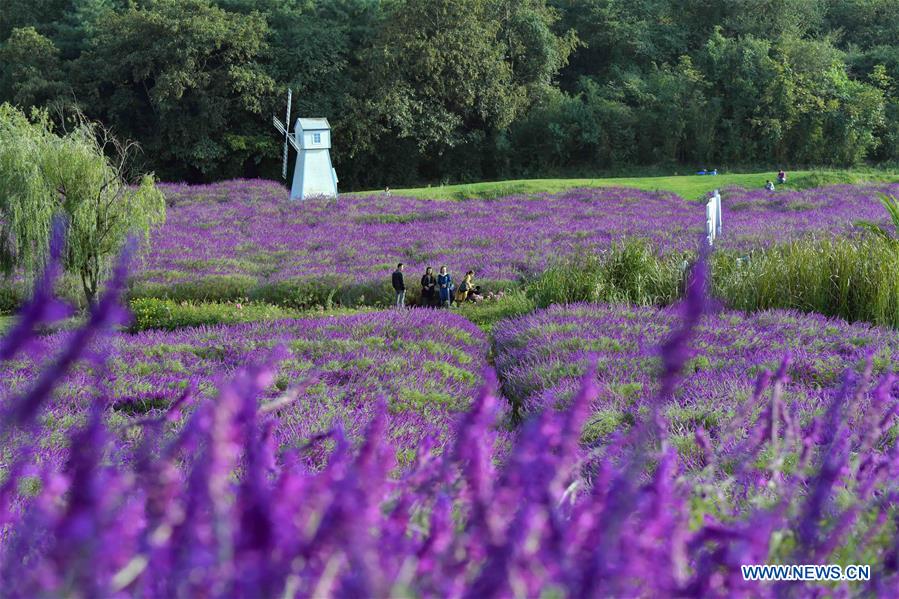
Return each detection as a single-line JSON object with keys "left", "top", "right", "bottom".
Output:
{"left": 698, "top": 28, "right": 884, "bottom": 165}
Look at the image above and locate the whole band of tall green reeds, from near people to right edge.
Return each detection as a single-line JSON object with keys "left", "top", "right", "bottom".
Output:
{"left": 525, "top": 236, "right": 899, "bottom": 328}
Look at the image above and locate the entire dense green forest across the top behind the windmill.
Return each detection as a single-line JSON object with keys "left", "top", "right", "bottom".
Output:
{"left": 0, "top": 0, "right": 899, "bottom": 190}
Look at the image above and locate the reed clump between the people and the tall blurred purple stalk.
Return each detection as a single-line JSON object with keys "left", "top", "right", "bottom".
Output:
{"left": 526, "top": 240, "right": 684, "bottom": 307}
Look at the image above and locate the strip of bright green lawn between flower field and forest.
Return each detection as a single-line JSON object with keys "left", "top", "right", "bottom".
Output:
{"left": 357, "top": 171, "right": 899, "bottom": 200}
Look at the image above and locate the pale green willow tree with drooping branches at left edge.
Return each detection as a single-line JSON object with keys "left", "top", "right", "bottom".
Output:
{"left": 0, "top": 104, "right": 165, "bottom": 304}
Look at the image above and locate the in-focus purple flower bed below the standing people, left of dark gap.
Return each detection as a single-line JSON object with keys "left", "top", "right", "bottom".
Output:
{"left": 0, "top": 310, "right": 487, "bottom": 468}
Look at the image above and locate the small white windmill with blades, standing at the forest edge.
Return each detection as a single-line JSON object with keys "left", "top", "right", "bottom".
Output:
{"left": 272, "top": 89, "right": 337, "bottom": 200}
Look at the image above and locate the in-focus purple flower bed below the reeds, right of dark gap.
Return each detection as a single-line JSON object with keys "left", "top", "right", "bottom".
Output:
{"left": 494, "top": 304, "right": 899, "bottom": 452}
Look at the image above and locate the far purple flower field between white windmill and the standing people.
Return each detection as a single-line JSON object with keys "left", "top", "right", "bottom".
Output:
{"left": 145, "top": 181, "right": 699, "bottom": 282}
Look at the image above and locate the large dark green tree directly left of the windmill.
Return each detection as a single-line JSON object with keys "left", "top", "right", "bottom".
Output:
{"left": 77, "top": 0, "right": 277, "bottom": 178}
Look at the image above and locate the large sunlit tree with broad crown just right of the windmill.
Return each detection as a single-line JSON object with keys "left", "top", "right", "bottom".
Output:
{"left": 341, "top": 0, "right": 576, "bottom": 185}
